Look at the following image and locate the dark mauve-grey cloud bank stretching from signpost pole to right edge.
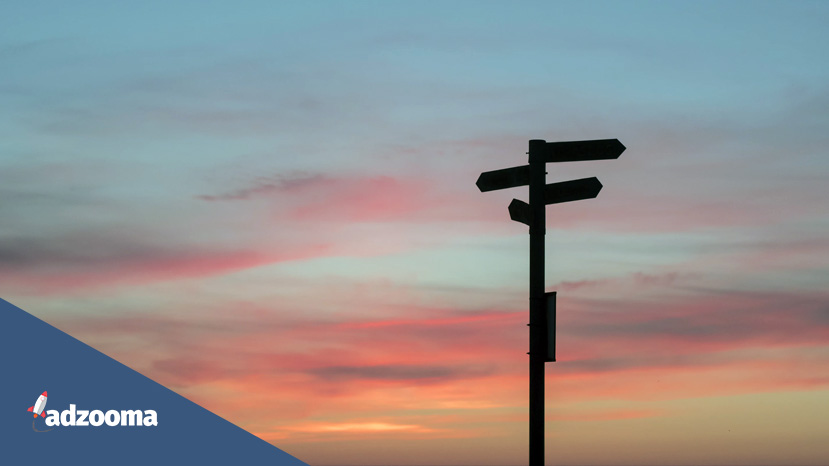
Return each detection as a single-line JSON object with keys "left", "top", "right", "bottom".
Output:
{"left": 560, "top": 290, "right": 829, "bottom": 351}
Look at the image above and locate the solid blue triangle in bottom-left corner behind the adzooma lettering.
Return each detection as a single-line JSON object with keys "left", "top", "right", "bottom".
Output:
{"left": 0, "top": 299, "right": 305, "bottom": 466}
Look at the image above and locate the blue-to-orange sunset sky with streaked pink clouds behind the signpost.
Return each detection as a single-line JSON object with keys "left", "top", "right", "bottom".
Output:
{"left": 0, "top": 0, "right": 829, "bottom": 466}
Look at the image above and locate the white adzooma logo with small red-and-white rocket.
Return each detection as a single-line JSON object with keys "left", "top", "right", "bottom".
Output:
{"left": 29, "top": 392, "right": 158, "bottom": 427}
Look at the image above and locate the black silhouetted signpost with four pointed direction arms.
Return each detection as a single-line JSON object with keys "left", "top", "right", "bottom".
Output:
{"left": 475, "top": 139, "right": 625, "bottom": 466}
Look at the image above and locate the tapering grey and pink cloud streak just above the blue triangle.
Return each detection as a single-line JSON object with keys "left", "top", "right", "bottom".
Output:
{"left": 0, "top": 231, "right": 329, "bottom": 294}
